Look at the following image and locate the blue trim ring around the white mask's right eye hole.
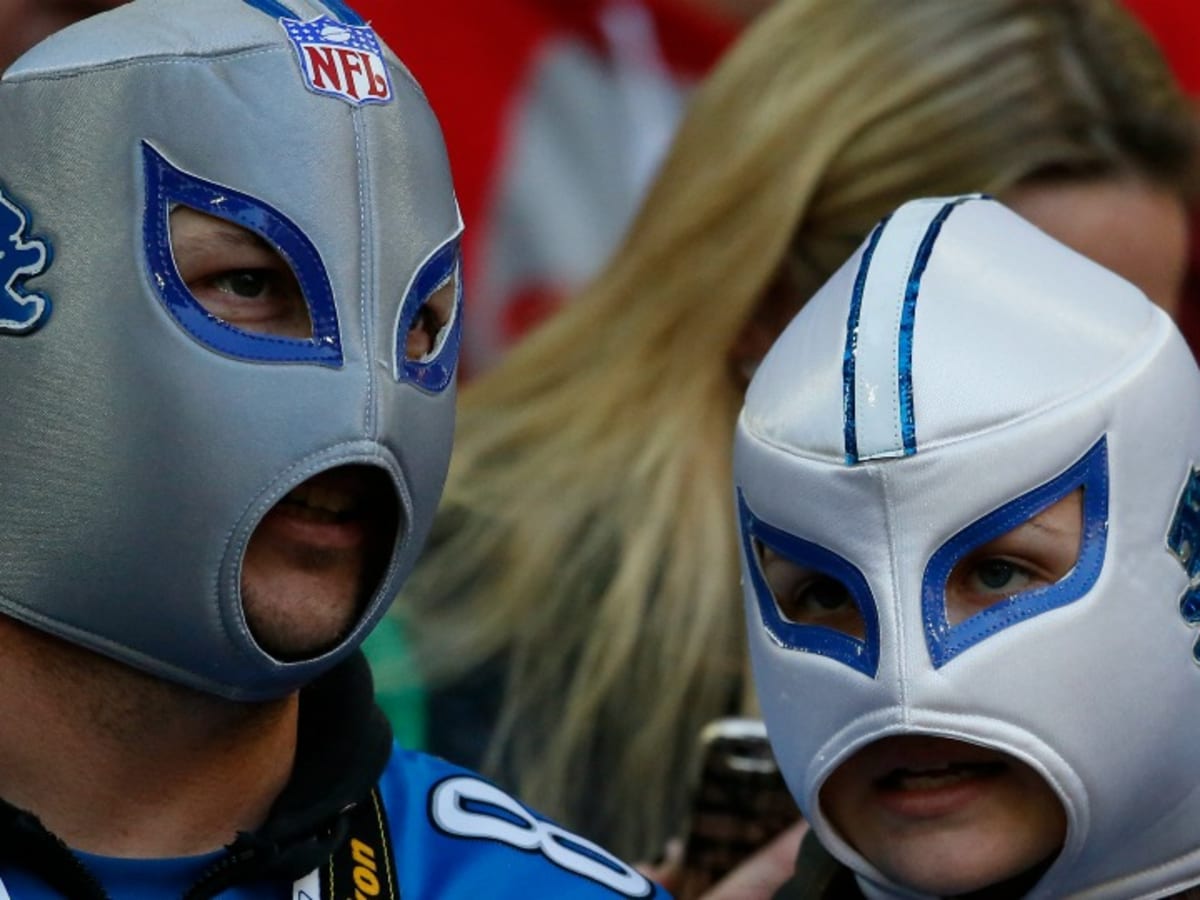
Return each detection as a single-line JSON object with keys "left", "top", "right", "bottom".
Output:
{"left": 920, "top": 437, "right": 1109, "bottom": 668}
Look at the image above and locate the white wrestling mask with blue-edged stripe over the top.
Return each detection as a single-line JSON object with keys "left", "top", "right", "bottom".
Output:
{"left": 734, "top": 197, "right": 1200, "bottom": 900}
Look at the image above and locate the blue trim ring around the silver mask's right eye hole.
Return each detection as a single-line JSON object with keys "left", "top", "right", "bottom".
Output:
{"left": 395, "top": 236, "right": 462, "bottom": 394}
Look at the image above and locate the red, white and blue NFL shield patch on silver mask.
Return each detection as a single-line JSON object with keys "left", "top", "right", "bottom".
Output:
{"left": 280, "top": 16, "right": 391, "bottom": 107}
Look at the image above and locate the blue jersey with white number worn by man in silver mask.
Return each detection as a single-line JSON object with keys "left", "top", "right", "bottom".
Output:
{"left": 0, "top": 748, "right": 667, "bottom": 900}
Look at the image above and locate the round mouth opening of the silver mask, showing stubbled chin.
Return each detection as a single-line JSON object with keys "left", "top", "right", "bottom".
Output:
{"left": 241, "top": 464, "right": 401, "bottom": 662}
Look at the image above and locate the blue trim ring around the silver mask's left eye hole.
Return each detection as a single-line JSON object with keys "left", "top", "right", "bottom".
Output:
{"left": 142, "top": 142, "right": 343, "bottom": 368}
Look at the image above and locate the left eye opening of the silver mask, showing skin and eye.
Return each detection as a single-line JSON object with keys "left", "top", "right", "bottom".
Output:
{"left": 168, "top": 204, "right": 312, "bottom": 340}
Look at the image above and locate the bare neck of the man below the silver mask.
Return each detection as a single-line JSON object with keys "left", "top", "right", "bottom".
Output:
{"left": 0, "top": 616, "right": 299, "bottom": 858}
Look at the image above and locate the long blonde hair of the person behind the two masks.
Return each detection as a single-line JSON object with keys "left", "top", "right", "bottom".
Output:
{"left": 402, "top": 0, "right": 1193, "bottom": 858}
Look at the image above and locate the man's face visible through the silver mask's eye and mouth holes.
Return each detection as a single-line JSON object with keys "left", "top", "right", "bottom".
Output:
{"left": 170, "top": 208, "right": 415, "bottom": 660}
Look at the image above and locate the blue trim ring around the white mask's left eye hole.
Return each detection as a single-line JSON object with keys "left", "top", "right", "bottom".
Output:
{"left": 738, "top": 490, "right": 880, "bottom": 678}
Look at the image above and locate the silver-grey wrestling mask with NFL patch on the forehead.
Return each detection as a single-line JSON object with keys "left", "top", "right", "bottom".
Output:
{"left": 0, "top": 0, "right": 462, "bottom": 700}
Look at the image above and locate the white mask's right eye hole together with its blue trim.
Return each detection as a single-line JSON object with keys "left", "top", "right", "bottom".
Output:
{"left": 922, "top": 437, "right": 1109, "bottom": 667}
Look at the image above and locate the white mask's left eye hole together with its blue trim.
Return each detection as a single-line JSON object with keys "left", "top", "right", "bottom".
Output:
{"left": 738, "top": 491, "right": 880, "bottom": 678}
